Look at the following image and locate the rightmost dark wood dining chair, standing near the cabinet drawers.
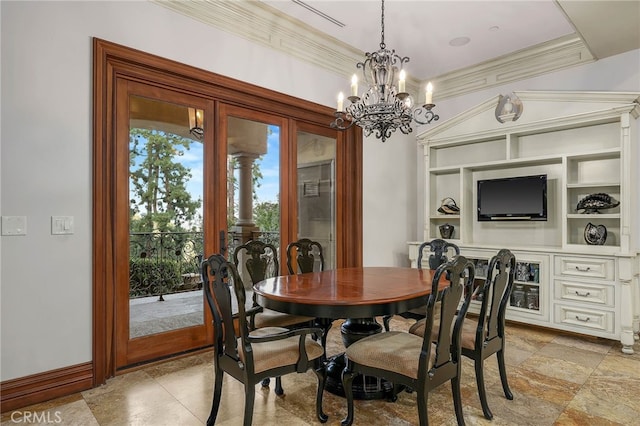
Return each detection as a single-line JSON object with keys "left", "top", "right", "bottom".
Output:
{"left": 409, "top": 249, "right": 516, "bottom": 420}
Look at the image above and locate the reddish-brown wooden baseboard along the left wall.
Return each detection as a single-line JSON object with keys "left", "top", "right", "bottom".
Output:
{"left": 0, "top": 362, "right": 93, "bottom": 413}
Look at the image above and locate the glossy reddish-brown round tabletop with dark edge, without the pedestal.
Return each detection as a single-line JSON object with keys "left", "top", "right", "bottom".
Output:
{"left": 253, "top": 266, "right": 446, "bottom": 319}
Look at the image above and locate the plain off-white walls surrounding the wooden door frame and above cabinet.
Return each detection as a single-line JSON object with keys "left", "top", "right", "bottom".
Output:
{"left": 0, "top": 0, "right": 640, "bottom": 381}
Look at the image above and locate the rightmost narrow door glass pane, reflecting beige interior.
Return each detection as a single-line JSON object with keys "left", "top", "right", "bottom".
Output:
{"left": 297, "top": 132, "right": 336, "bottom": 269}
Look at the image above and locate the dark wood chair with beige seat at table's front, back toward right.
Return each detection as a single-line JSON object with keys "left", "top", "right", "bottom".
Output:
{"left": 342, "top": 256, "right": 475, "bottom": 426}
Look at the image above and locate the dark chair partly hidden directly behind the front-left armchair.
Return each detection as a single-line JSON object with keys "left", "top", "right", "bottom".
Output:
{"left": 232, "top": 240, "right": 315, "bottom": 395}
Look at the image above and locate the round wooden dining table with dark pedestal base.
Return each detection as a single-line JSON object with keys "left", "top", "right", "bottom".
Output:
{"left": 253, "top": 267, "right": 448, "bottom": 399}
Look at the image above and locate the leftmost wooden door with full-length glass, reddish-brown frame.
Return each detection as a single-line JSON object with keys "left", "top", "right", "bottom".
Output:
{"left": 114, "top": 78, "right": 216, "bottom": 369}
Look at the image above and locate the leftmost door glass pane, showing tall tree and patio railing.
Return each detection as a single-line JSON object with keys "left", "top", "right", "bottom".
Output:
{"left": 129, "top": 96, "right": 204, "bottom": 338}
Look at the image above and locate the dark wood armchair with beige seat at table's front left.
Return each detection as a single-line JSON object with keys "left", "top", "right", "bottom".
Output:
{"left": 201, "top": 255, "right": 328, "bottom": 426}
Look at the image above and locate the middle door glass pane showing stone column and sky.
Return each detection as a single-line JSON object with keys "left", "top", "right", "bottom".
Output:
{"left": 227, "top": 117, "right": 280, "bottom": 284}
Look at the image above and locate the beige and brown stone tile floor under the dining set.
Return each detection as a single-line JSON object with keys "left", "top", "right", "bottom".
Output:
{"left": 1, "top": 317, "right": 640, "bottom": 426}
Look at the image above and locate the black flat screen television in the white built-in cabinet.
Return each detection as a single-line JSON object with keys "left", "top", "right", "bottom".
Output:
{"left": 477, "top": 175, "right": 547, "bottom": 222}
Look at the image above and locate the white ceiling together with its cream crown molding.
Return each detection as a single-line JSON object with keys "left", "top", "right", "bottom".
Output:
{"left": 150, "top": 0, "right": 640, "bottom": 99}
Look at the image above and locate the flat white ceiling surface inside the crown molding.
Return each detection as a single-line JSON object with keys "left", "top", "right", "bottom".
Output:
{"left": 262, "top": 0, "right": 640, "bottom": 80}
